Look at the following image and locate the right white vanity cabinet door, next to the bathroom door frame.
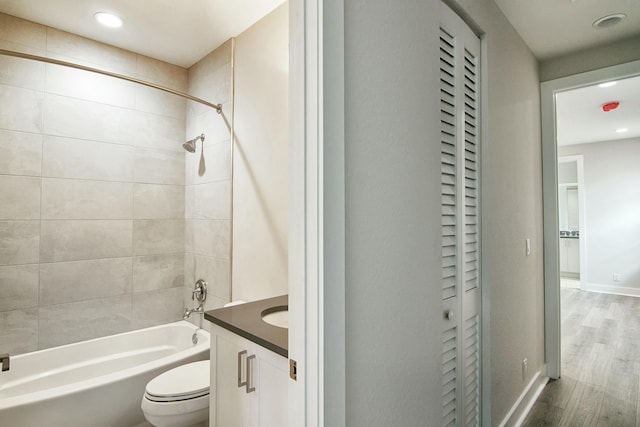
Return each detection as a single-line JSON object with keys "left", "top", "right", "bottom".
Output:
{"left": 253, "top": 344, "right": 289, "bottom": 427}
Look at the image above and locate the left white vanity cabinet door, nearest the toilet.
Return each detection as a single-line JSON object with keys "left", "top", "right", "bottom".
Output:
{"left": 212, "top": 330, "right": 256, "bottom": 427}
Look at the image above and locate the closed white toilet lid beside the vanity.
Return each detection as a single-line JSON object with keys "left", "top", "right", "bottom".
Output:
{"left": 145, "top": 360, "right": 210, "bottom": 402}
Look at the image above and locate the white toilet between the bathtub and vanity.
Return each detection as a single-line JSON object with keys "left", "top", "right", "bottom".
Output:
{"left": 140, "top": 360, "right": 210, "bottom": 427}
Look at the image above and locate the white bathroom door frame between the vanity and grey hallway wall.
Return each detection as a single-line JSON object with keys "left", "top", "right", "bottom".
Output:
{"left": 288, "top": 0, "right": 346, "bottom": 427}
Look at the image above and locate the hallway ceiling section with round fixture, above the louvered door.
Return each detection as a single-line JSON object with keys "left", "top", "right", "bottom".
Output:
{"left": 495, "top": 0, "right": 640, "bottom": 60}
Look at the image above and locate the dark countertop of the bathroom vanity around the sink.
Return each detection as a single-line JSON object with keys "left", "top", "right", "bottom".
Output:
{"left": 204, "top": 295, "right": 289, "bottom": 357}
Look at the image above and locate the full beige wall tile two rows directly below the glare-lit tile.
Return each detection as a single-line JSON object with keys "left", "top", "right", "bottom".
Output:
{"left": 42, "top": 135, "right": 135, "bottom": 182}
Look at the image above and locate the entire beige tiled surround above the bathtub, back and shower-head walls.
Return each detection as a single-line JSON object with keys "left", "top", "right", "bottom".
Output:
{"left": 0, "top": 14, "right": 195, "bottom": 354}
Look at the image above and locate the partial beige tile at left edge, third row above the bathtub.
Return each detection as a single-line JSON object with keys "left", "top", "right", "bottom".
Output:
{"left": 0, "top": 221, "right": 40, "bottom": 265}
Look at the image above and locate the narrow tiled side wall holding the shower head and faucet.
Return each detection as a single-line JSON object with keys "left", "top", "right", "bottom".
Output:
{"left": 184, "top": 40, "right": 232, "bottom": 328}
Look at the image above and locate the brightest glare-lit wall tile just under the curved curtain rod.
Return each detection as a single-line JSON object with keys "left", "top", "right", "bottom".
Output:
{"left": 45, "top": 64, "right": 135, "bottom": 109}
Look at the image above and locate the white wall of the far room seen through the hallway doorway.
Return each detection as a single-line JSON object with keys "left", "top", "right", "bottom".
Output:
{"left": 558, "top": 138, "right": 640, "bottom": 293}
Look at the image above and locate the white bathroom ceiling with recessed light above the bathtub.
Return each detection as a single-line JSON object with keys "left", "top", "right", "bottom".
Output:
{"left": 0, "top": 0, "right": 284, "bottom": 67}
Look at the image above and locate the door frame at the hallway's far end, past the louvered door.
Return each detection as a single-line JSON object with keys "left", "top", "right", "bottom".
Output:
{"left": 540, "top": 60, "right": 640, "bottom": 378}
